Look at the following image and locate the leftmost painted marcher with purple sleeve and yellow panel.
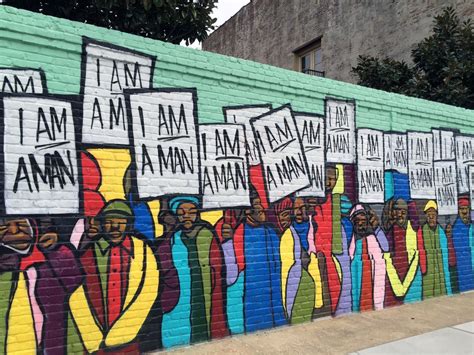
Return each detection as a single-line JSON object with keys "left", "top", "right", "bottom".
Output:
{"left": 0, "top": 218, "right": 82, "bottom": 354}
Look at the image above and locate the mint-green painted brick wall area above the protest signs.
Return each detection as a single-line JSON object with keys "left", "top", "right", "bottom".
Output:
{"left": 0, "top": 6, "right": 474, "bottom": 133}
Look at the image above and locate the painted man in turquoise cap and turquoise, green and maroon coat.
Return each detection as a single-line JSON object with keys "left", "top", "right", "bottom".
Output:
{"left": 162, "top": 196, "right": 228, "bottom": 347}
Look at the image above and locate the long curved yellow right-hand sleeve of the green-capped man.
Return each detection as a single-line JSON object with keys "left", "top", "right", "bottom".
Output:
{"left": 105, "top": 242, "right": 160, "bottom": 347}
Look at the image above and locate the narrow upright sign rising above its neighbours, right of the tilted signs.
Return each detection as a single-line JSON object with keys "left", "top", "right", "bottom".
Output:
{"left": 325, "top": 98, "right": 356, "bottom": 164}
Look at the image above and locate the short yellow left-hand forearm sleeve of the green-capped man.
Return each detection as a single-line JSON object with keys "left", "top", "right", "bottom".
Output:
{"left": 69, "top": 285, "right": 104, "bottom": 353}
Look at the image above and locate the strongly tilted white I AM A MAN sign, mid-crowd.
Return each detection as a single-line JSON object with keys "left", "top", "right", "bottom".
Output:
{"left": 251, "top": 105, "right": 311, "bottom": 203}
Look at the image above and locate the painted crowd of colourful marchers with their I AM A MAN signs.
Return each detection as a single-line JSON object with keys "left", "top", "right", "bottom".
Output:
{"left": 0, "top": 38, "right": 474, "bottom": 354}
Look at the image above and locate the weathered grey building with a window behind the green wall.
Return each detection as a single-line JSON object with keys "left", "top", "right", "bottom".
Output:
{"left": 202, "top": 0, "right": 474, "bottom": 82}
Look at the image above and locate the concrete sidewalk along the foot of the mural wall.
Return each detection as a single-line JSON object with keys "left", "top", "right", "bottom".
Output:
{"left": 160, "top": 292, "right": 474, "bottom": 354}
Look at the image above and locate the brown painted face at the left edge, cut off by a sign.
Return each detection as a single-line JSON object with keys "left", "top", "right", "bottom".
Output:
{"left": 0, "top": 218, "right": 33, "bottom": 254}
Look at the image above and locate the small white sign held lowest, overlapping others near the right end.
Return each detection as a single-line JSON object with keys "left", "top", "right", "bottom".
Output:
{"left": 434, "top": 160, "right": 458, "bottom": 216}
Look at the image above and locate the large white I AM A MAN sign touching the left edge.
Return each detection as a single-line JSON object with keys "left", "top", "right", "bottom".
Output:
{"left": 2, "top": 96, "right": 80, "bottom": 216}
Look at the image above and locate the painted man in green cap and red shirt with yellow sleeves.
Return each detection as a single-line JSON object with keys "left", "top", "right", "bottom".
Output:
{"left": 69, "top": 200, "right": 159, "bottom": 353}
